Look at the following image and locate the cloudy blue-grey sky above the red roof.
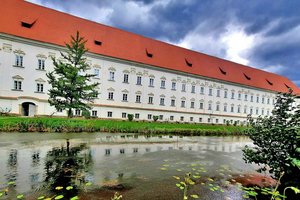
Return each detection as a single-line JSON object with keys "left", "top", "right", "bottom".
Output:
{"left": 28, "top": 0, "right": 300, "bottom": 86}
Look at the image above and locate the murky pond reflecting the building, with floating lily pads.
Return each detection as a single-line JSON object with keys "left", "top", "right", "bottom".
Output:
{"left": 0, "top": 133, "right": 255, "bottom": 200}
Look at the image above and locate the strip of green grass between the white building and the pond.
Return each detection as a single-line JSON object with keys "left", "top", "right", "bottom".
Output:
{"left": 0, "top": 117, "right": 246, "bottom": 135}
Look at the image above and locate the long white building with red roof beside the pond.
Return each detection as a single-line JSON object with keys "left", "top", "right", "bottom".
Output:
{"left": 0, "top": 0, "right": 300, "bottom": 124}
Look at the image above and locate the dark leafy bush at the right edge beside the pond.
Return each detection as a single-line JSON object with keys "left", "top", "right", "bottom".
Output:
{"left": 243, "top": 92, "right": 300, "bottom": 188}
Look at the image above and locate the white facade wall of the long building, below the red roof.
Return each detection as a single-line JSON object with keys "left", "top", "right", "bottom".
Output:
{"left": 0, "top": 35, "right": 276, "bottom": 123}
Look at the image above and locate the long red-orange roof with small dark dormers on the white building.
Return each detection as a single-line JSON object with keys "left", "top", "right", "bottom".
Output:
{"left": 0, "top": 0, "right": 300, "bottom": 94}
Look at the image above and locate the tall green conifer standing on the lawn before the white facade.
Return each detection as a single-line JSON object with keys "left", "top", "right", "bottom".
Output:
{"left": 47, "top": 32, "right": 99, "bottom": 117}
